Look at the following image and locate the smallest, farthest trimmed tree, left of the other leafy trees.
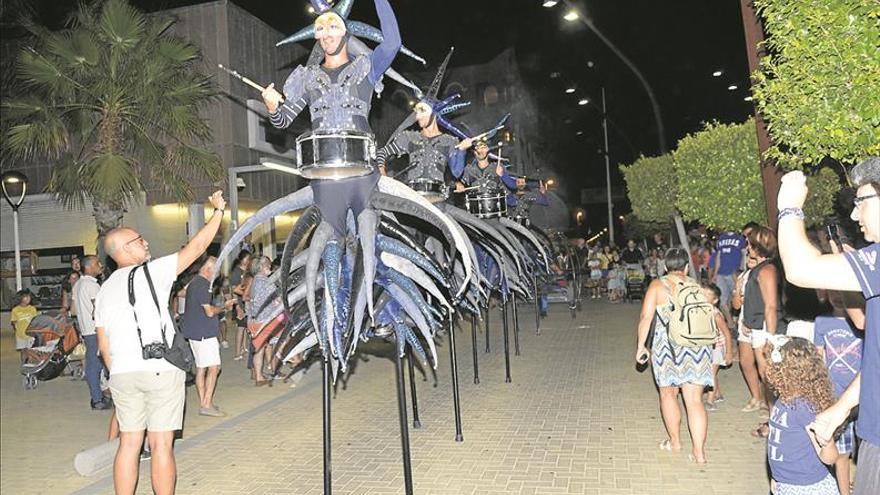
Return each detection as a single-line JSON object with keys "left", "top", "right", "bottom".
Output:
{"left": 620, "top": 154, "right": 678, "bottom": 222}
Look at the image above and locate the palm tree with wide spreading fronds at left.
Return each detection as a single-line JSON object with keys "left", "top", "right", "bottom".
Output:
{"left": 3, "top": 0, "right": 223, "bottom": 254}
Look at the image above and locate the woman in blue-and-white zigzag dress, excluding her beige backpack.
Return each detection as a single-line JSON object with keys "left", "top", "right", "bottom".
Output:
{"left": 636, "top": 248, "right": 712, "bottom": 464}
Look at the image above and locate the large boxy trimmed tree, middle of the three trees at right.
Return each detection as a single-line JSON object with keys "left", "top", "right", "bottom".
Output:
{"left": 672, "top": 120, "right": 767, "bottom": 230}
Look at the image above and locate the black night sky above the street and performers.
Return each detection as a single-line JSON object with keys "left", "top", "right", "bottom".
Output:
{"left": 3, "top": 0, "right": 752, "bottom": 229}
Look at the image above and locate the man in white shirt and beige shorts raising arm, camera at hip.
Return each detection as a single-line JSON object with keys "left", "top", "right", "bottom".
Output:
{"left": 95, "top": 191, "right": 226, "bottom": 495}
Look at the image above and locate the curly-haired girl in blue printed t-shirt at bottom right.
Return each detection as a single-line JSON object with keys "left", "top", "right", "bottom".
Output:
{"left": 763, "top": 335, "right": 839, "bottom": 495}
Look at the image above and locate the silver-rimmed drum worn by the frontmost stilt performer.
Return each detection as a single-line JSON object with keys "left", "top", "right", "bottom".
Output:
{"left": 296, "top": 131, "right": 376, "bottom": 179}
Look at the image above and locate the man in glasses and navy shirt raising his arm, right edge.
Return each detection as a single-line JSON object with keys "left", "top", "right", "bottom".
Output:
{"left": 777, "top": 157, "right": 880, "bottom": 495}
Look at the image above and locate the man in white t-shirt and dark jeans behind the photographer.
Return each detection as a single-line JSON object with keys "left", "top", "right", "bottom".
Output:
{"left": 71, "top": 255, "right": 113, "bottom": 410}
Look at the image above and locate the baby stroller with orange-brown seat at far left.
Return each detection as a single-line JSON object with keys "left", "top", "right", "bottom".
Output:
{"left": 21, "top": 311, "right": 80, "bottom": 390}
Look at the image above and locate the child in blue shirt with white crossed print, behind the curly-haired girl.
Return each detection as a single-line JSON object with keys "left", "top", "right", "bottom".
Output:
{"left": 813, "top": 292, "right": 864, "bottom": 495}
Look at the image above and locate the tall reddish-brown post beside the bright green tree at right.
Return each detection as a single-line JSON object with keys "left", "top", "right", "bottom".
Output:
{"left": 739, "top": 0, "right": 782, "bottom": 229}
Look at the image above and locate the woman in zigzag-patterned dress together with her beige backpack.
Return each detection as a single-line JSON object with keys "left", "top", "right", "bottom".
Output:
{"left": 636, "top": 248, "right": 718, "bottom": 464}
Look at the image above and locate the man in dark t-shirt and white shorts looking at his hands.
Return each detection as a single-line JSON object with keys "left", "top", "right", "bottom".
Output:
{"left": 183, "top": 256, "right": 235, "bottom": 417}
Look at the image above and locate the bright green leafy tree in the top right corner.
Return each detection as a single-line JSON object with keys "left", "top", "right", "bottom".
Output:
{"left": 752, "top": 0, "right": 880, "bottom": 168}
